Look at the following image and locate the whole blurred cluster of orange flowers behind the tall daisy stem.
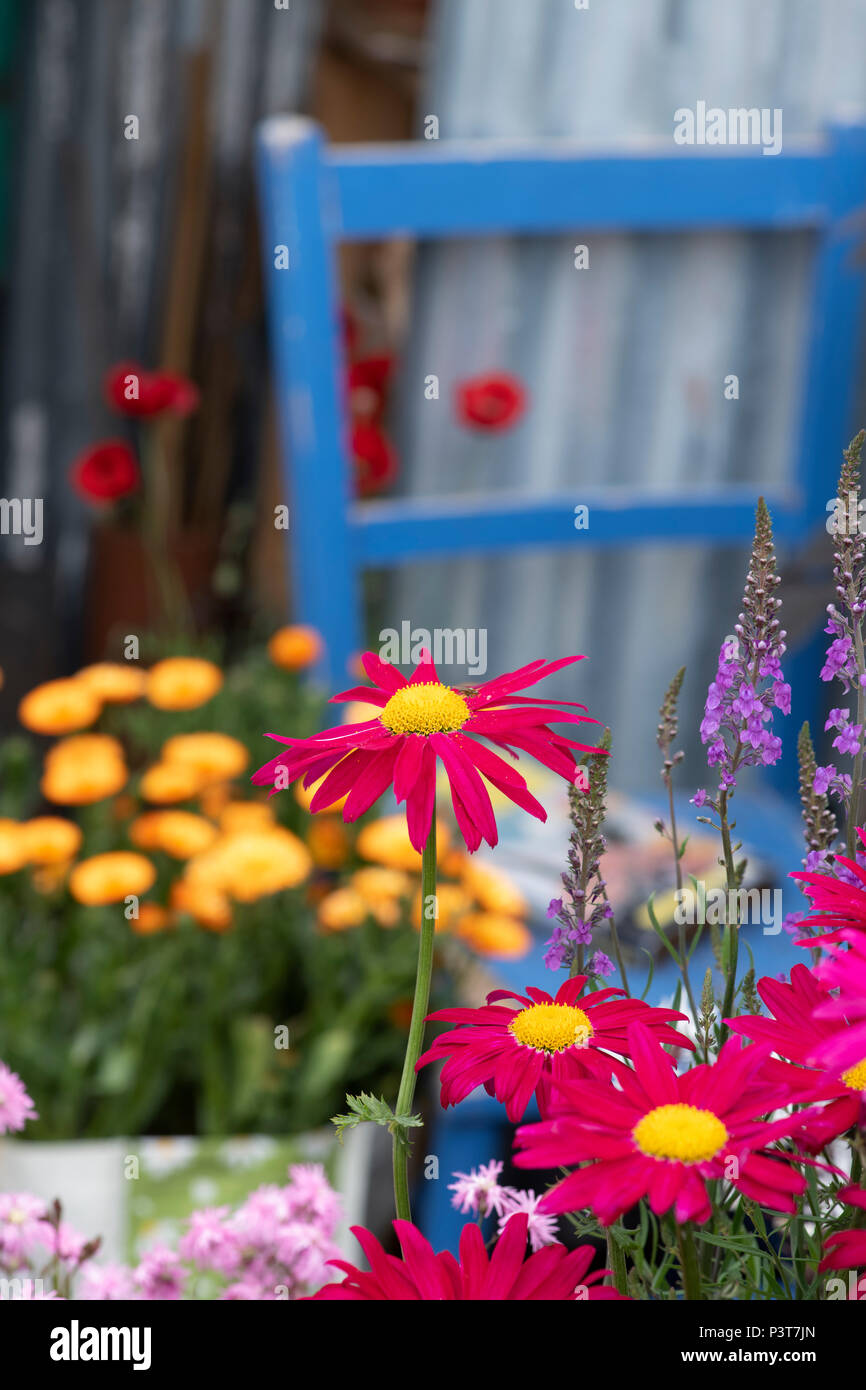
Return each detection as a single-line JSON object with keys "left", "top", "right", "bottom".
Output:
{"left": 0, "top": 626, "right": 531, "bottom": 958}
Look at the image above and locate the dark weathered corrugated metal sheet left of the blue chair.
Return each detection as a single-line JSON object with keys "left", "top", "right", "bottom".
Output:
{"left": 0, "top": 0, "right": 321, "bottom": 711}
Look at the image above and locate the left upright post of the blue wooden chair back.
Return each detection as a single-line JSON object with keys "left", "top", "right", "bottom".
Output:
{"left": 257, "top": 117, "right": 360, "bottom": 684}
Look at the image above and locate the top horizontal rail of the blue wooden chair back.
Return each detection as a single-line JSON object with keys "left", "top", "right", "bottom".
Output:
{"left": 327, "top": 140, "right": 845, "bottom": 240}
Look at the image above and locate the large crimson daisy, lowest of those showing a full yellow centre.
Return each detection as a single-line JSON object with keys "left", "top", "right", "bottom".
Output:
{"left": 514, "top": 1023, "right": 806, "bottom": 1226}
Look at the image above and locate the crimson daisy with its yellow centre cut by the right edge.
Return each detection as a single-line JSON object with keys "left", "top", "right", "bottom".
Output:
{"left": 724, "top": 965, "right": 866, "bottom": 1152}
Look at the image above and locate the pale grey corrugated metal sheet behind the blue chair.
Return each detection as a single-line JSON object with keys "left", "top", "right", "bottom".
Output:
{"left": 385, "top": 0, "right": 866, "bottom": 788}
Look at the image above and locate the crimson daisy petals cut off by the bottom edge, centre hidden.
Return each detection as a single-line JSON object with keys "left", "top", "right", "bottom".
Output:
{"left": 313, "top": 1213, "right": 623, "bottom": 1302}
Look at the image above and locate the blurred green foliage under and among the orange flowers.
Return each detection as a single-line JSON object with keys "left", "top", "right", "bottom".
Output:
{"left": 0, "top": 636, "right": 444, "bottom": 1140}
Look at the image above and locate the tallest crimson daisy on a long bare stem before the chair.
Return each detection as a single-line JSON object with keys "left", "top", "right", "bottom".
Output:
{"left": 253, "top": 651, "right": 598, "bottom": 852}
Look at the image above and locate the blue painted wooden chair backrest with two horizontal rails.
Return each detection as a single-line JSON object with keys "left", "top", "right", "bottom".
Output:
{"left": 257, "top": 117, "right": 866, "bottom": 681}
